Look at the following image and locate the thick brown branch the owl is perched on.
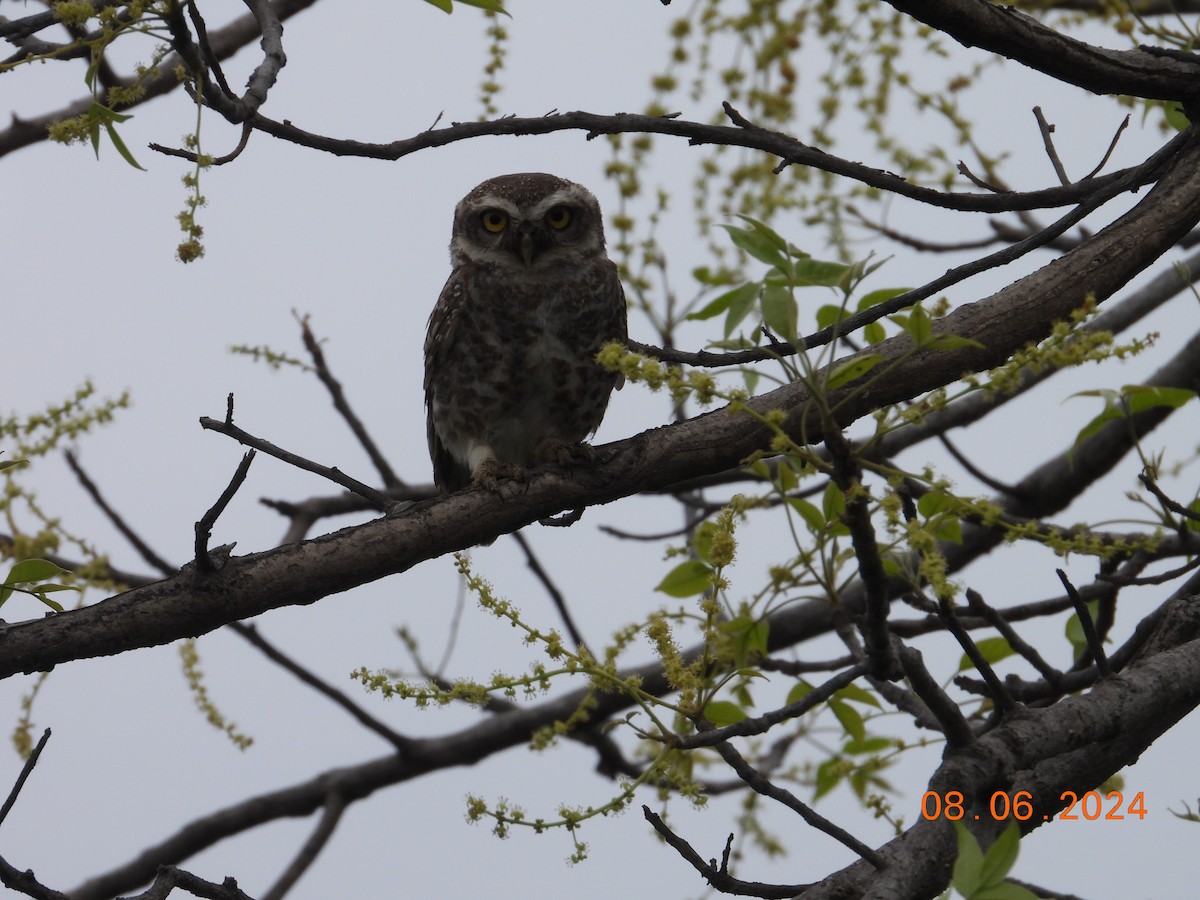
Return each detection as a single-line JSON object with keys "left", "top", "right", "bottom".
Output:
{"left": 0, "top": 136, "right": 1200, "bottom": 676}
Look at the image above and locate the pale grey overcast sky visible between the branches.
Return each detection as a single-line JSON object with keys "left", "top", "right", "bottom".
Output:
{"left": 0, "top": 0, "right": 1200, "bottom": 900}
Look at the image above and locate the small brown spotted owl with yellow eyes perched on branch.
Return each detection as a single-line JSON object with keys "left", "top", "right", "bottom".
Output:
{"left": 425, "top": 173, "right": 626, "bottom": 492}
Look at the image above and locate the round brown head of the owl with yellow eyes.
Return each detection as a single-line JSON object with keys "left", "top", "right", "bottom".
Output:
{"left": 450, "top": 172, "right": 604, "bottom": 271}
